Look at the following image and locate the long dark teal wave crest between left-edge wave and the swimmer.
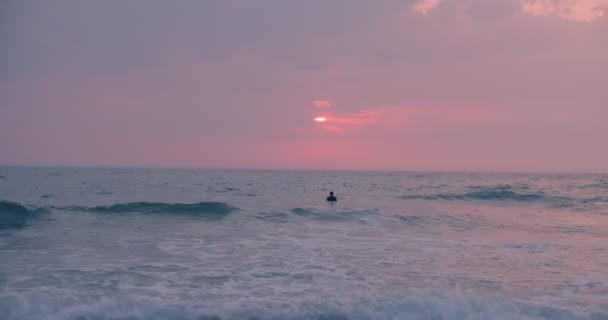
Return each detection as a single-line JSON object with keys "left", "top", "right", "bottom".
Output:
{"left": 65, "top": 202, "right": 238, "bottom": 216}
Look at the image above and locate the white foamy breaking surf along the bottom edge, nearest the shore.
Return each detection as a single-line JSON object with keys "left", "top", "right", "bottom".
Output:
{"left": 0, "top": 289, "right": 608, "bottom": 320}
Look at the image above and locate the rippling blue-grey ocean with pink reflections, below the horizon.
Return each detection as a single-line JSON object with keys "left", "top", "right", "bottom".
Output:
{"left": 0, "top": 167, "right": 608, "bottom": 320}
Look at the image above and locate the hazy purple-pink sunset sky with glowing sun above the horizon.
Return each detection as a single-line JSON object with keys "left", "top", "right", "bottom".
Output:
{"left": 0, "top": 0, "right": 608, "bottom": 172}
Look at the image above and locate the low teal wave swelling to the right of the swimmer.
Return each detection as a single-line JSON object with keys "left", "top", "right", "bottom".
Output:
{"left": 400, "top": 186, "right": 576, "bottom": 206}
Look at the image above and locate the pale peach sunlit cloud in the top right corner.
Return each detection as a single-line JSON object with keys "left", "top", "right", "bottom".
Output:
{"left": 521, "top": 0, "right": 608, "bottom": 22}
